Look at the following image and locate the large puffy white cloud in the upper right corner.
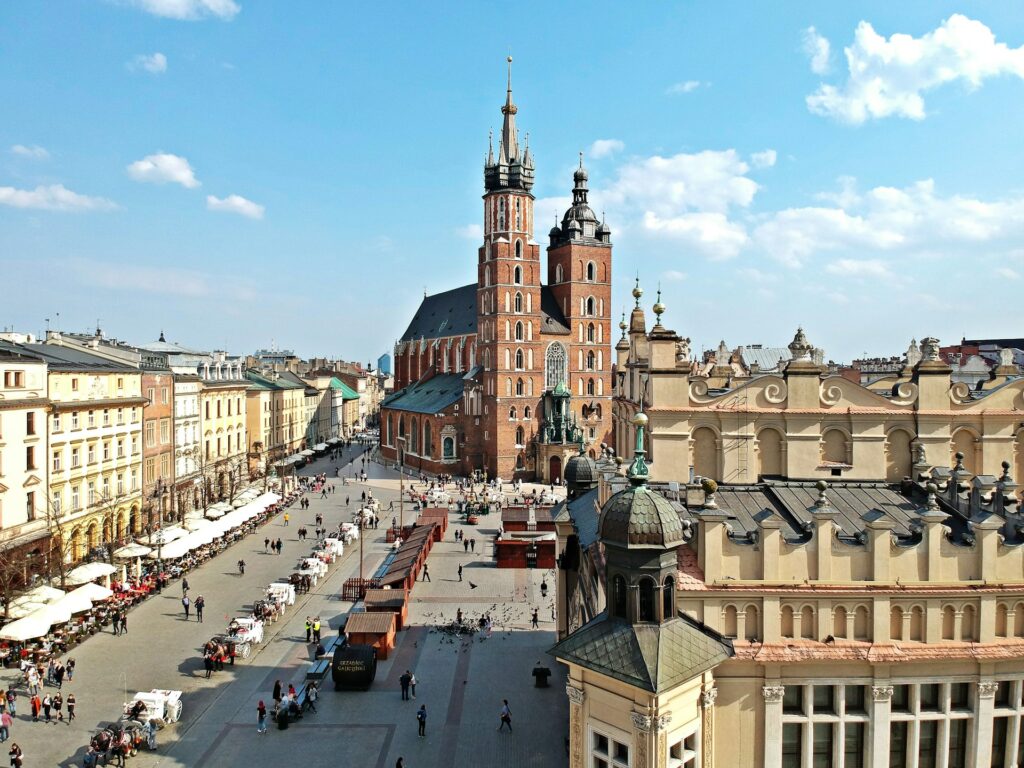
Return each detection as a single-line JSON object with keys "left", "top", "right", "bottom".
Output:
{"left": 807, "top": 13, "right": 1024, "bottom": 125}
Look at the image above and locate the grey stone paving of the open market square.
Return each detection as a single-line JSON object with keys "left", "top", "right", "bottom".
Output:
{"left": 3, "top": 450, "right": 567, "bottom": 768}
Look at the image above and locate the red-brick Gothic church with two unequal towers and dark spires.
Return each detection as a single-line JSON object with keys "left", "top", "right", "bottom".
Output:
{"left": 380, "top": 57, "right": 611, "bottom": 482}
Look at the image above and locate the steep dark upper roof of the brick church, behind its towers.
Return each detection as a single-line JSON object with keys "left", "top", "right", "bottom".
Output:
{"left": 399, "top": 283, "right": 571, "bottom": 341}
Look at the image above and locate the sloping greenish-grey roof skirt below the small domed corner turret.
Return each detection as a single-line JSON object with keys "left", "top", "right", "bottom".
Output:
{"left": 549, "top": 612, "right": 732, "bottom": 693}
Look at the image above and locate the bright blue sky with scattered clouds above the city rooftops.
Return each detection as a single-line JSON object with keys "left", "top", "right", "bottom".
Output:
{"left": 0, "top": 0, "right": 1024, "bottom": 360}
